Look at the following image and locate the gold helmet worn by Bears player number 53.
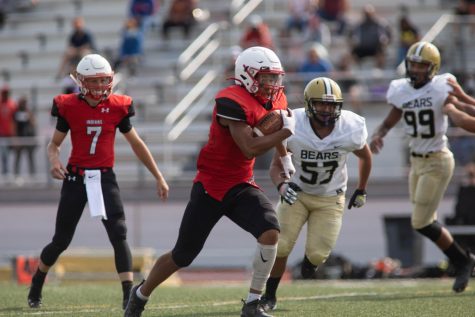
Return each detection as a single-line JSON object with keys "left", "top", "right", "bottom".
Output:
{"left": 303, "top": 77, "right": 343, "bottom": 126}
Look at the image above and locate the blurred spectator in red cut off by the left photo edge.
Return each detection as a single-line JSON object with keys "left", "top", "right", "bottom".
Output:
{"left": 0, "top": 86, "right": 17, "bottom": 176}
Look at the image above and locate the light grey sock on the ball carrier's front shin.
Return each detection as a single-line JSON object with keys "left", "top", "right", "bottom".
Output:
{"left": 251, "top": 243, "right": 277, "bottom": 291}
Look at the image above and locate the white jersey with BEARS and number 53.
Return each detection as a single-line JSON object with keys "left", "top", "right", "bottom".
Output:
{"left": 287, "top": 108, "right": 368, "bottom": 196}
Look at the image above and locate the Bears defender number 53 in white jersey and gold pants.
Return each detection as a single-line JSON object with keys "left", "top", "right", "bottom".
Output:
{"left": 261, "top": 77, "right": 371, "bottom": 310}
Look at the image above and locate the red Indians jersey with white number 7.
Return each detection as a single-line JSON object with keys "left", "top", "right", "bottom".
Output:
{"left": 53, "top": 94, "right": 133, "bottom": 168}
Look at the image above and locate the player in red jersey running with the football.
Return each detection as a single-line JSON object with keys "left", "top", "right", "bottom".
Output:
{"left": 124, "top": 47, "right": 295, "bottom": 317}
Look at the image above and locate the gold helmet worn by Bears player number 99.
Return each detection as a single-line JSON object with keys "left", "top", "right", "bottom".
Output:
{"left": 405, "top": 42, "right": 440, "bottom": 88}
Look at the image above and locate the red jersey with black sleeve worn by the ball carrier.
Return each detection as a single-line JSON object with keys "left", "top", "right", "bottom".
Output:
{"left": 194, "top": 86, "right": 287, "bottom": 200}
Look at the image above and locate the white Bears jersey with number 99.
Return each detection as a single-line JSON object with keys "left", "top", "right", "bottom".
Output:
{"left": 386, "top": 73, "right": 455, "bottom": 154}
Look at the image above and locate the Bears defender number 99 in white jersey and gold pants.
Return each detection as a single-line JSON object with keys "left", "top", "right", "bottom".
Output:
{"left": 370, "top": 42, "right": 475, "bottom": 292}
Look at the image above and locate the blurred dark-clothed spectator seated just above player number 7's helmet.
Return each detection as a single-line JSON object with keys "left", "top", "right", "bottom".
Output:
{"left": 56, "top": 17, "right": 95, "bottom": 79}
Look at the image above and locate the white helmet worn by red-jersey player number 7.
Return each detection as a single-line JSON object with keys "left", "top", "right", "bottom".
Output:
{"left": 71, "top": 54, "right": 114, "bottom": 100}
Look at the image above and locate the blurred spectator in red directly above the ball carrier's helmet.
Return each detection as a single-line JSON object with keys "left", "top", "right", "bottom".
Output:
{"left": 239, "top": 14, "right": 274, "bottom": 49}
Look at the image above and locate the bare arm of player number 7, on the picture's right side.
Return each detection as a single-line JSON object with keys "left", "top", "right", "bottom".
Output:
{"left": 124, "top": 128, "right": 170, "bottom": 200}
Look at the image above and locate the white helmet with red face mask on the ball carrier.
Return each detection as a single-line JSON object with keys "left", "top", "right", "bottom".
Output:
{"left": 234, "top": 46, "right": 284, "bottom": 103}
